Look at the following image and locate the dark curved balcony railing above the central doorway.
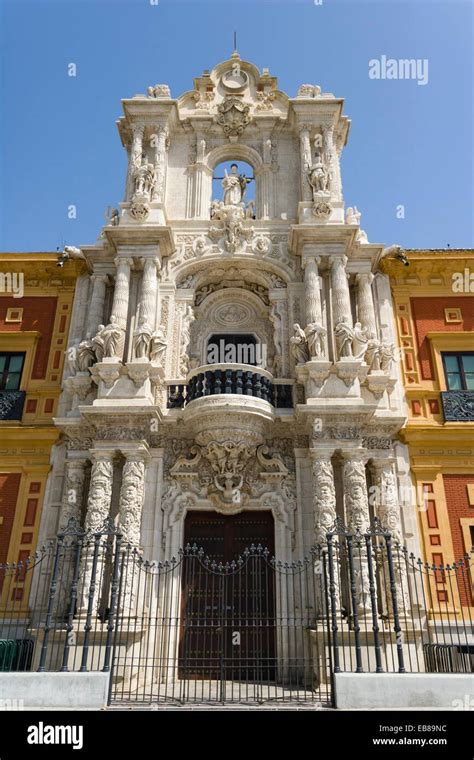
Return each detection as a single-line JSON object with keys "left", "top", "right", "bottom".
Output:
{"left": 168, "top": 365, "right": 293, "bottom": 409}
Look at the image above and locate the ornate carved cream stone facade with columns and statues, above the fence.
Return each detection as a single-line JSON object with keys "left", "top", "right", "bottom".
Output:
{"left": 42, "top": 53, "right": 418, "bottom": 576}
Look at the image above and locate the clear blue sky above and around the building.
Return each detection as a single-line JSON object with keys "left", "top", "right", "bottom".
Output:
{"left": 0, "top": 0, "right": 474, "bottom": 251}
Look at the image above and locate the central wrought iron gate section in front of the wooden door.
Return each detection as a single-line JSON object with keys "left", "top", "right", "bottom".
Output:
{"left": 111, "top": 546, "right": 331, "bottom": 704}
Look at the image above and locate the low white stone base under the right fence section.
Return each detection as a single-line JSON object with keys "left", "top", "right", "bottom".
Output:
{"left": 334, "top": 673, "right": 474, "bottom": 710}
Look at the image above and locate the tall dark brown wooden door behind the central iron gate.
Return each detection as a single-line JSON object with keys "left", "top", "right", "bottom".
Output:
{"left": 179, "top": 512, "right": 275, "bottom": 681}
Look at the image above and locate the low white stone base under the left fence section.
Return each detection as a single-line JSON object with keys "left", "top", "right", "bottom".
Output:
{"left": 0, "top": 672, "right": 110, "bottom": 710}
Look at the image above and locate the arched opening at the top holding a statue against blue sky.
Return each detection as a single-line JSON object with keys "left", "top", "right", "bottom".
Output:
{"left": 211, "top": 161, "right": 255, "bottom": 219}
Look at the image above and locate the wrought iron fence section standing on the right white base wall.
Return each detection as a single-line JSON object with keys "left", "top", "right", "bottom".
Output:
{"left": 327, "top": 520, "right": 474, "bottom": 673}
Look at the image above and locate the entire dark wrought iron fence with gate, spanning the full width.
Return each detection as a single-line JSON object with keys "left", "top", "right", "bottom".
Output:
{"left": 0, "top": 522, "right": 474, "bottom": 705}
